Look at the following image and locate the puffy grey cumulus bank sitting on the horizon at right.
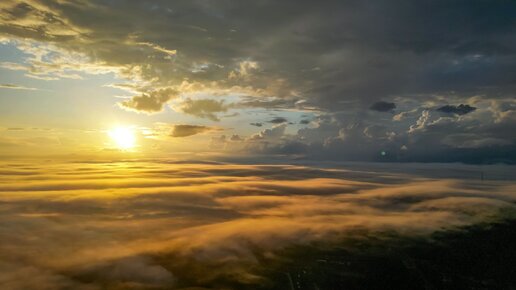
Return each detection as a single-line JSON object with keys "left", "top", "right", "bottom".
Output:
{"left": 252, "top": 100, "right": 516, "bottom": 164}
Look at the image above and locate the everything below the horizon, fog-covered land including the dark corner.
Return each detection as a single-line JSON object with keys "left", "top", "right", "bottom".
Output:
{"left": 0, "top": 160, "right": 516, "bottom": 290}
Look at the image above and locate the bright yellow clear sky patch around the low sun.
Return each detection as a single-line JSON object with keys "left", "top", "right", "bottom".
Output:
{"left": 0, "top": 40, "right": 310, "bottom": 154}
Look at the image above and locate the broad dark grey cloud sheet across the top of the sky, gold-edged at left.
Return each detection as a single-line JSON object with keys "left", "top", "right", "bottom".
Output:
{"left": 2, "top": 1, "right": 516, "bottom": 111}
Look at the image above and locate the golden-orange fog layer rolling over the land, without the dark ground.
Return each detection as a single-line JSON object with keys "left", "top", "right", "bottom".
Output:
{"left": 0, "top": 160, "right": 516, "bottom": 290}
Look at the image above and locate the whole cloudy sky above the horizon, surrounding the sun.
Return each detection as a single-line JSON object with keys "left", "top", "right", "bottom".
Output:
{"left": 0, "top": 0, "right": 516, "bottom": 163}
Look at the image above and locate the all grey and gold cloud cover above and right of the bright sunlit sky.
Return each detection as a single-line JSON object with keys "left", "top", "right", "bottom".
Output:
{"left": 0, "top": 0, "right": 516, "bottom": 162}
